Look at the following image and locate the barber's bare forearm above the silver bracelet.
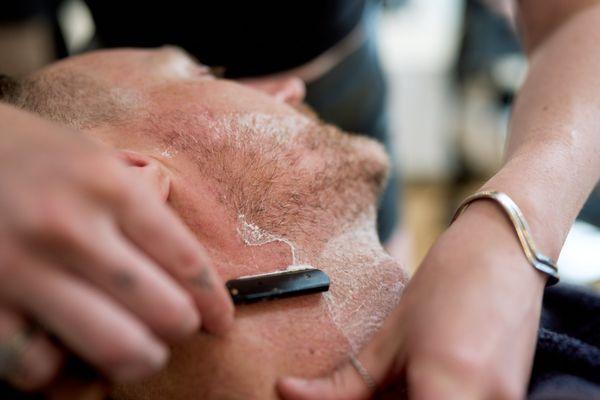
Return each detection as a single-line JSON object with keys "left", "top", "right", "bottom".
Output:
{"left": 485, "top": 5, "right": 600, "bottom": 258}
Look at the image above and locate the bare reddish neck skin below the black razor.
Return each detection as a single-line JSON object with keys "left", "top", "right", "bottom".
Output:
{"left": 117, "top": 294, "right": 350, "bottom": 399}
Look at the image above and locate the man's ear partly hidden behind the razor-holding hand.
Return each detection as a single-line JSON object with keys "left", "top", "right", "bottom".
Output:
{"left": 117, "top": 150, "right": 171, "bottom": 202}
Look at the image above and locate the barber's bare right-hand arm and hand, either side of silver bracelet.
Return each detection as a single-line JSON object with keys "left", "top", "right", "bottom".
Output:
{"left": 278, "top": 0, "right": 600, "bottom": 400}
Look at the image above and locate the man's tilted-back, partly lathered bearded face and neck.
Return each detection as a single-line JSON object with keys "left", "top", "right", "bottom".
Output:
{"left": 37, "top": 48, "right": 405, "bottom": 399}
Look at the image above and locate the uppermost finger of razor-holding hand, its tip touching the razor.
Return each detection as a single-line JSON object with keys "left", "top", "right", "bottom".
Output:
{"left": 116, "top": 194, "right": 233, "bottom": 333}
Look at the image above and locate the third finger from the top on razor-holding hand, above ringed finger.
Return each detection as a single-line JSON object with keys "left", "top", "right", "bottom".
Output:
{"left": 0, "top": 261, "right": 168, "bottom": 380}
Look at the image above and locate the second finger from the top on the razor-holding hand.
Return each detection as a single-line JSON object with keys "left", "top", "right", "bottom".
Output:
{"left": 53, "top": 219, "right": 199, "bottom": 339}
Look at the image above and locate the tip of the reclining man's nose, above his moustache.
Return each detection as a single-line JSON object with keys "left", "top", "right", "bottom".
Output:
{"left": 240, "top": 75, "right": 306, "bottom": 104}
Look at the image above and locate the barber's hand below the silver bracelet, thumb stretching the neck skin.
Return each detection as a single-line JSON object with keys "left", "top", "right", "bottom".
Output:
{"left": 278, "top": 202, "right": 545, "bottom": 400}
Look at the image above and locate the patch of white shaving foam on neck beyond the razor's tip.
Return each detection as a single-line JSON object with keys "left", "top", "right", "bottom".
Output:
{"left": 304, "top": 208, "right": 408, "bottom": 353}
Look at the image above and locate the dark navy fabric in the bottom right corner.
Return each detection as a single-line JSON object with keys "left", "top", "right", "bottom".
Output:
{"left": 529, "top": 285, "right": 600, "bottom": 400}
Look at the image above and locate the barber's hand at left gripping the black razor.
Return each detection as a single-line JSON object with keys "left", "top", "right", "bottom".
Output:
{"left": 0, "top": 105, "right": 233, "bottom": 388}
